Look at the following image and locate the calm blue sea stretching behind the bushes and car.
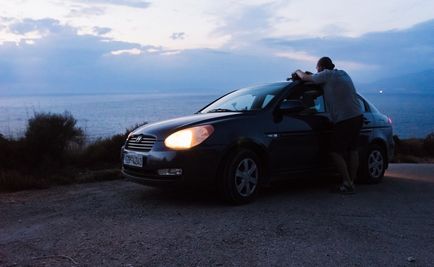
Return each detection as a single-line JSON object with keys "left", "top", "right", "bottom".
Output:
{"left": 0, "top": 93, "right": 434, "bottom": 141}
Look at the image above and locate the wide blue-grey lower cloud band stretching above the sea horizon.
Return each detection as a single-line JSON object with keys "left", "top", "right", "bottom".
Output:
{"left": 0, "top": 17, "right": 434, "bottom": 94}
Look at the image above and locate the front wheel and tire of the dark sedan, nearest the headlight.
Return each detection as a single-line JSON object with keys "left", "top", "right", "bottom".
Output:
{"left": 222, "top": 149, "right": 262, "bottom": 205}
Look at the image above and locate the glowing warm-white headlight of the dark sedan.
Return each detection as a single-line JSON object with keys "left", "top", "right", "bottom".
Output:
{"left": 164, "top": 125, "right": 214, "bottom": 150}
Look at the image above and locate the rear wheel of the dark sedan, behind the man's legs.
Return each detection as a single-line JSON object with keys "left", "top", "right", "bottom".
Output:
{"left": 358, "top": 144, "right": 387, "bottom": 184}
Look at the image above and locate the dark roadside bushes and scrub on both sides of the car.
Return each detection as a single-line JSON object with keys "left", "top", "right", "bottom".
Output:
{"left": 0, "top": 112, "right": 434, "bottom": 191}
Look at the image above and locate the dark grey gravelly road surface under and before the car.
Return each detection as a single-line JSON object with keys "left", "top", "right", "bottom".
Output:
{"left": 0, "top": 164, "right": 434, "bottom": 266}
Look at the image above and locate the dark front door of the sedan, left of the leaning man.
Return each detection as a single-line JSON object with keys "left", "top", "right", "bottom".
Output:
{"left": 270, "top": 84, "right": 330, "bottom": 176}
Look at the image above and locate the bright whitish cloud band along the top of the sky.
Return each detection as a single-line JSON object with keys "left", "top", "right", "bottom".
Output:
{"left": 0, "top": 0, "right": 434, "bottom": 50}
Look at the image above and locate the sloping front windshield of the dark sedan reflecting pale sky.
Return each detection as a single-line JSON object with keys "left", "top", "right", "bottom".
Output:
{"left": 200, "top": 83, "right": 288, "bottom": 113}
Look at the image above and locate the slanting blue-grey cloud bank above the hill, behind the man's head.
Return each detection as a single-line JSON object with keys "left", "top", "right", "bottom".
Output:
{"left": 262, "top": 20, "right": 434, "bottom": 79}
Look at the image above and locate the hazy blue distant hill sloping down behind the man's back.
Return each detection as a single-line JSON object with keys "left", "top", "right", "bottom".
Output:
{"left": 359, "top": 69, "right": 434, "bottom": 94}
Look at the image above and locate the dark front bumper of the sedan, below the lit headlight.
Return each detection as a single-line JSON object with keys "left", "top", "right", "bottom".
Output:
{"left": 121, "top": 141, "right": 223, "bottom": 187}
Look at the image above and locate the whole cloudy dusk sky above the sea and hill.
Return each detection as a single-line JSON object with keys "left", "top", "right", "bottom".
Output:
{"left": 0, "top": 0, "right": 434, "bottom": 94}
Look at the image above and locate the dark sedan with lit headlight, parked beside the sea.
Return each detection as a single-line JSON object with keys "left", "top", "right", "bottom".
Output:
{"left": 122, "top": 81, "right": 394, "bottom": 203}
